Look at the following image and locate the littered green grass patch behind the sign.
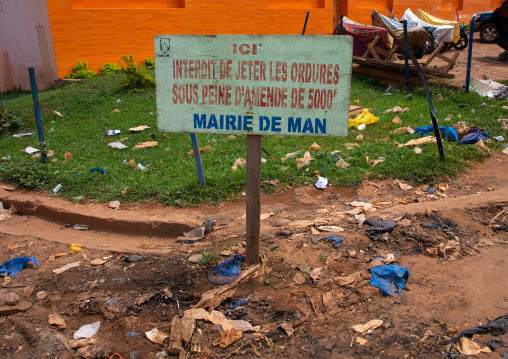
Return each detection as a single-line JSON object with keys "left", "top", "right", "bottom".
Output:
{"left": 0, "top": 70, "right": 506, "bottom": 206}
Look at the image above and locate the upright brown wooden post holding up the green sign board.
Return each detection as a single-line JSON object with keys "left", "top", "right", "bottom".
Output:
{"left": 245, "top": 135, "right": 263, "bottom": 265}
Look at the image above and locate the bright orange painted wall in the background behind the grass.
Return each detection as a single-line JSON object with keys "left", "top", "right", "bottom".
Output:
{"left": 47, "top": 0, "right": 502, "bottom": 77}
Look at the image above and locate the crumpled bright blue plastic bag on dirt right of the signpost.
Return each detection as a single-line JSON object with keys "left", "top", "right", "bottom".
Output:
{"left": 370, "top": 264, "right": 409, "bottom": 297}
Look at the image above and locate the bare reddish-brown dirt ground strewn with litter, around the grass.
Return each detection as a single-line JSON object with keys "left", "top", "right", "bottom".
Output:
{"left": 0, "top": 37, "right": 508, "bottom": 359}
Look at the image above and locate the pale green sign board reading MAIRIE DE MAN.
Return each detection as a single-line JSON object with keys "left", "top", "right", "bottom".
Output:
{"left": 155, "top": 35, "right": 353, "bottom": 136}
